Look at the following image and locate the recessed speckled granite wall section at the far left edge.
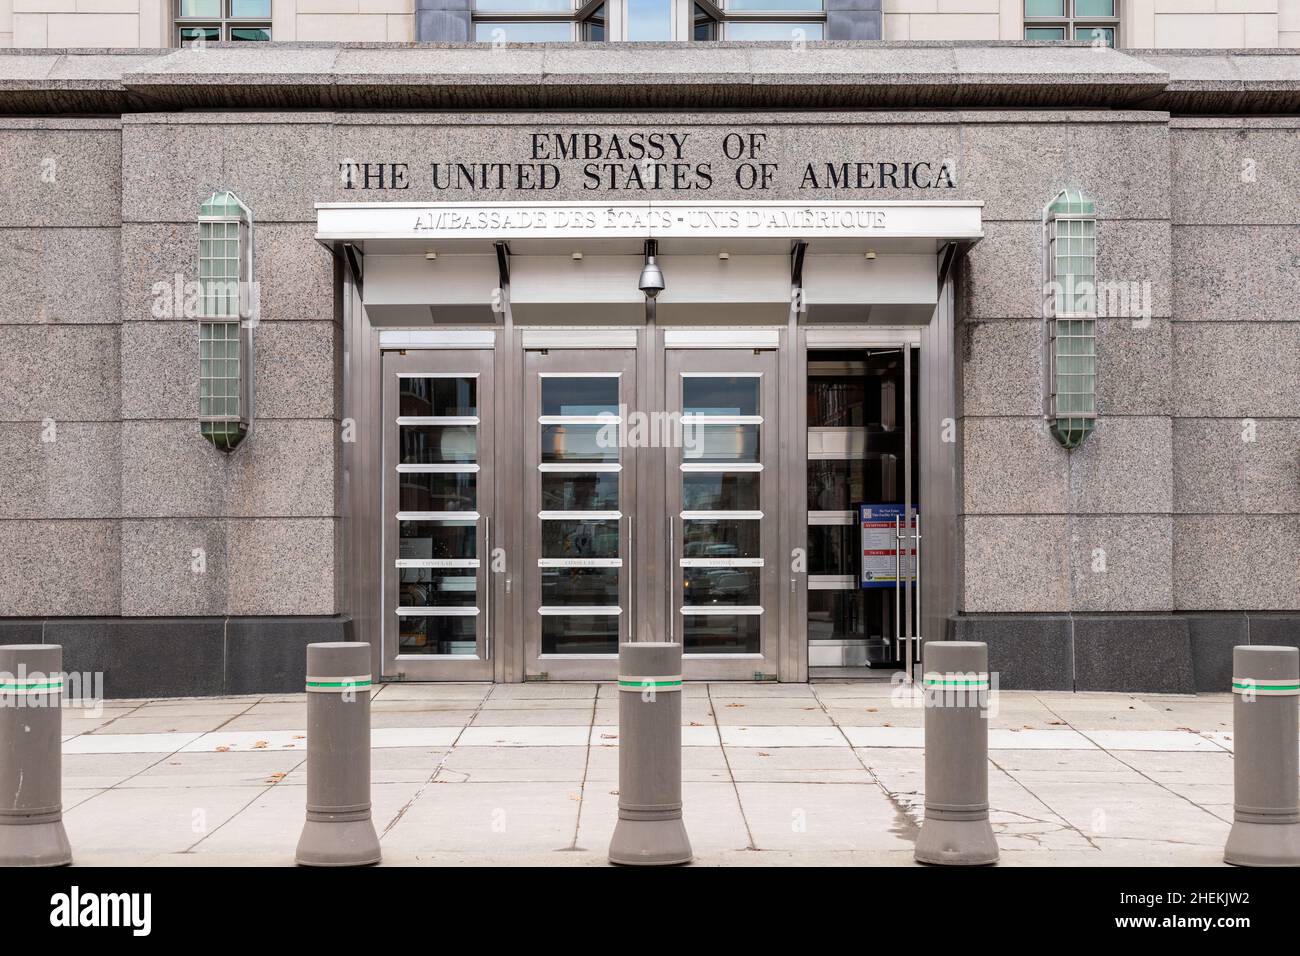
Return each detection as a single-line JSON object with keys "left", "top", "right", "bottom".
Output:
{"left": 0, "top": 118, "right": 121, "bottom": 617}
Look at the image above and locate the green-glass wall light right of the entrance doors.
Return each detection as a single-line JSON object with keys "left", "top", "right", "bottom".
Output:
{"left": 1043, "top": 189, "right": 1097, "bottom": 449}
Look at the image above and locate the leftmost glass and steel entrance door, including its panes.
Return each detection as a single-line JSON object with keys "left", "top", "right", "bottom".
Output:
{"left": 382, "top": 350, "right": 494, "bottom": 680}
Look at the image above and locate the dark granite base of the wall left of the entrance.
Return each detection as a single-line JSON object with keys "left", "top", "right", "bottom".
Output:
{"left": 0, "top": 618, "right": 351, "bottom": 698}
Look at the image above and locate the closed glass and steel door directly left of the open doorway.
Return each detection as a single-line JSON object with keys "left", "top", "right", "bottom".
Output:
{"left": 666, "top": 349, "right": 779, "bottom": 679}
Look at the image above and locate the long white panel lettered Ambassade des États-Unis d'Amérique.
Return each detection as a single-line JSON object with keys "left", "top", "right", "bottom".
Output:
{"left": 316, "top": 202, "right": 984, "bottom": 242}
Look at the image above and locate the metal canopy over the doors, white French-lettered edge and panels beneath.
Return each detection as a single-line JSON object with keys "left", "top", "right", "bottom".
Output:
{"left": 316, "top": 202, "right": 983, "bottom": 328}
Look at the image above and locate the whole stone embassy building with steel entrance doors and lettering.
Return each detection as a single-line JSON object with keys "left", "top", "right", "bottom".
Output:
{"left": 0, "top": 11, "right": 1300, "bottom": 697}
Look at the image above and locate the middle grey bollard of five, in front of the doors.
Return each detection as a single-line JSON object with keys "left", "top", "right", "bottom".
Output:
{"left": 610, "top": 641, "right": 692, "bottom": 866}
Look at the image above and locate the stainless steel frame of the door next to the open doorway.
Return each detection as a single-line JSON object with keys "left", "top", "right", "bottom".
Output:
{"left": 664, "top": 343, "right": 785, "bottom": 680}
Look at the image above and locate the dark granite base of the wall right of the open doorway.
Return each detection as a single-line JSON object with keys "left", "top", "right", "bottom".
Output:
{"left": 948, "top": 611, "right": 1300, "bottom": 693}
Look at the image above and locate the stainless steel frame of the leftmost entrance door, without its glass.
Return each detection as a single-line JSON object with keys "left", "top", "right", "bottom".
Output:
{"left": 381, "top": 349, "right": 495, "bottom": 680}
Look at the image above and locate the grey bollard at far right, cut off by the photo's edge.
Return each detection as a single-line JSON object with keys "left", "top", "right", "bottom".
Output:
{"left": 1223, "top": 644, "right": 1300, "bottom": 866}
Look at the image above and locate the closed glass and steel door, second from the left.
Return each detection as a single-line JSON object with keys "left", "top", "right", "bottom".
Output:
{"left": 523, "top": 349, "right": 637, "bottom": 680}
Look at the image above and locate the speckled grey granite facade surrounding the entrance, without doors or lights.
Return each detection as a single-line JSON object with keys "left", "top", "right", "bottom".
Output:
{"left": 0, "top": 52, "right": 1300, "bottom": 693}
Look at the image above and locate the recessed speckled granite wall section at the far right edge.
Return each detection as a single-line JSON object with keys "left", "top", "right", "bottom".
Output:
{"left": 1170, "top": 118, "right": 1300, "bottom": 610}
